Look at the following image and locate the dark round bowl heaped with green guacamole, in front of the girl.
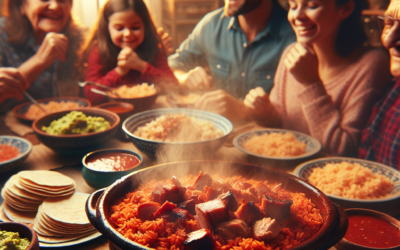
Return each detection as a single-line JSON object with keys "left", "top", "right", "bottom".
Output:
{"left": 32, "top": 108, "right": 120, "bottom": 156}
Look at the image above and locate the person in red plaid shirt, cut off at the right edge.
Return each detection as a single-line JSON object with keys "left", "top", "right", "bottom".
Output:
{"left": 358, "top": 0, "right": 400, "bottom": 169}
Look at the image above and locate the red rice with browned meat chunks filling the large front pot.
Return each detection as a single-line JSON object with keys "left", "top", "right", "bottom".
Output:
{"left": 109, "top": 172, "right": 323, "bottom": 250}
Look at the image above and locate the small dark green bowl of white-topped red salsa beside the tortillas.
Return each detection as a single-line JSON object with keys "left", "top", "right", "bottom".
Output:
{"left": 82, "top": 149, "right": 143, "bottom": 189}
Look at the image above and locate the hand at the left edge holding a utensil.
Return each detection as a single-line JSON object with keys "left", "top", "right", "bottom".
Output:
{"left": 0, "top": 68, "right": 29, "bottom": 103}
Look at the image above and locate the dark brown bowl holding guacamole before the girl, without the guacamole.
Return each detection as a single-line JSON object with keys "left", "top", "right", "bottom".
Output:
{"left": 32, "top": 108, "right": 120, "bottom": 156}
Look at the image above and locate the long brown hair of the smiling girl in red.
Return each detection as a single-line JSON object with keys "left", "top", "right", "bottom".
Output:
{"left": 82, "top": 0, "right": 162, "bottom": 72}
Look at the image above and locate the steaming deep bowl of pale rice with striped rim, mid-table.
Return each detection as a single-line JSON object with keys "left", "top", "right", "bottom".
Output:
{"left": 122, "top": 108, "right": 233, "bottom": 161}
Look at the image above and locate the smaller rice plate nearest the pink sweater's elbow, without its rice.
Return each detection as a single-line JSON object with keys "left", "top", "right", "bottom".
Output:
{"left": 233, "top": 129, "right": 321, "bottom": 160}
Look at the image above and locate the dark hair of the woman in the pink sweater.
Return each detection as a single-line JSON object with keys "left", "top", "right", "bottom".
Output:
{"left": 335, "top": 0, "right": 369, "bottom": 57}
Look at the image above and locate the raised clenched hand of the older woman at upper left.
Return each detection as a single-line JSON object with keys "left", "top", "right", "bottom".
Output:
{"left": 35, "top": 32, "right": 69, "bottom": 67}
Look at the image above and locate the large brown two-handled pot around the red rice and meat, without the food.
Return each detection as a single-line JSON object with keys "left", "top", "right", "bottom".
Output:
{"left": 86, "top": 161, "right": 347, "bottom": 250}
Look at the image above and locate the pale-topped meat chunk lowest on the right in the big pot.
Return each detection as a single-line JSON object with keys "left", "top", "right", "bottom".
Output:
{"left": 253, "top": 218, "right": 281, "bottom": 241}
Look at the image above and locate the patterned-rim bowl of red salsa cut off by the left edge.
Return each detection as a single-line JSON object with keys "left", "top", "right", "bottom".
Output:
{"left": 0, "top": 136, "right": 32, "bottom": 173}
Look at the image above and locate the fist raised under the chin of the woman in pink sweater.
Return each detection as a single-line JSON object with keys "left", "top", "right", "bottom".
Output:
{"left": 284, "top": 43, "right": 321, "bottom": 85}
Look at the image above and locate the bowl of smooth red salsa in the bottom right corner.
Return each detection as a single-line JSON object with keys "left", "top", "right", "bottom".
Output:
{"left": 336, "top": 208, "right": 400, "bottom": 250}
